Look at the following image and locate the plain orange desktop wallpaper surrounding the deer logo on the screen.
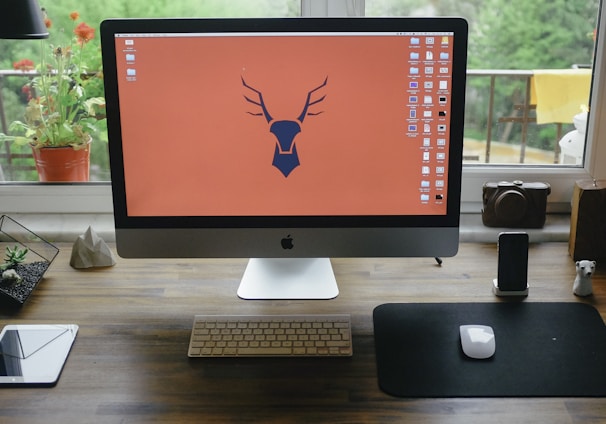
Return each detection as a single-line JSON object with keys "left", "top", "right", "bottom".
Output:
{"left": 116, "top": 36, "right": 448, "bottom": 216}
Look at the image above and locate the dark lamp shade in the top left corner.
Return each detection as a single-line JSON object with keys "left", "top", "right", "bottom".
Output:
{"left": 0, "top": 0, "right": 48, "bottom": 39}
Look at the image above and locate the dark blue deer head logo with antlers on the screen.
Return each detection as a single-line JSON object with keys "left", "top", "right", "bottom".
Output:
{"left": 242, "top": 77, "right": 328, "bottom": 177}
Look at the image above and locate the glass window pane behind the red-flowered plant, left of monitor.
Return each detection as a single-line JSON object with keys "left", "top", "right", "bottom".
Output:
{"left": 0, "top": 0, "right": 301, "bottom": 182}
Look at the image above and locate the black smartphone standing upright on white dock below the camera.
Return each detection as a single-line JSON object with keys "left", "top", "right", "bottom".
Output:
{"left": 497, "top": 232, "right": 528, "bottom": 292}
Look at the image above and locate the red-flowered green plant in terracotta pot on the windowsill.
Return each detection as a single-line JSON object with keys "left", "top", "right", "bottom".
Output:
{"left": 0, "top": 11, "right": 105, "bottom": 181}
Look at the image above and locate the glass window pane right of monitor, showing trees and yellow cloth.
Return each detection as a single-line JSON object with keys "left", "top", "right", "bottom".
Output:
{"left": 366, "top": 0, "right": 600, "bottom": 167}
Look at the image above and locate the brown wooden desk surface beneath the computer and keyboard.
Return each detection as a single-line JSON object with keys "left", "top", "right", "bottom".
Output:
{"left": 0, "top": 243, "right": 606, "bottom": 424}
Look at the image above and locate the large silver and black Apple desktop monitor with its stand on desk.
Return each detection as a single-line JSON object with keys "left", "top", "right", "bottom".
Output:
{"left": 101, "top": 18, "right": 467, "bottom": 299}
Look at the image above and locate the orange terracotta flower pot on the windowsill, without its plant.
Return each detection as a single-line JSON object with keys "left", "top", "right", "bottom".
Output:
{"left": 32, "top": 142, "right": 90, "bottom": 182}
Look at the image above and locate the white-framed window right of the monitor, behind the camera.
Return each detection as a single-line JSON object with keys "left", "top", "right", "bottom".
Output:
{"left": 365, "top": 0, "right": 606, "bottom": 212}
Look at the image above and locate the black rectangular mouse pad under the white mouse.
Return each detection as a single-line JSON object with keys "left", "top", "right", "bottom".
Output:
{"left": 373, "top": 302, "right": 606, "bottom": 397}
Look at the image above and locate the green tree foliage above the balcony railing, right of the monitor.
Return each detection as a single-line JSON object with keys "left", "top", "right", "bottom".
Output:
{"left": 469, "top": 0, "right": 599, "bottom": 69}
